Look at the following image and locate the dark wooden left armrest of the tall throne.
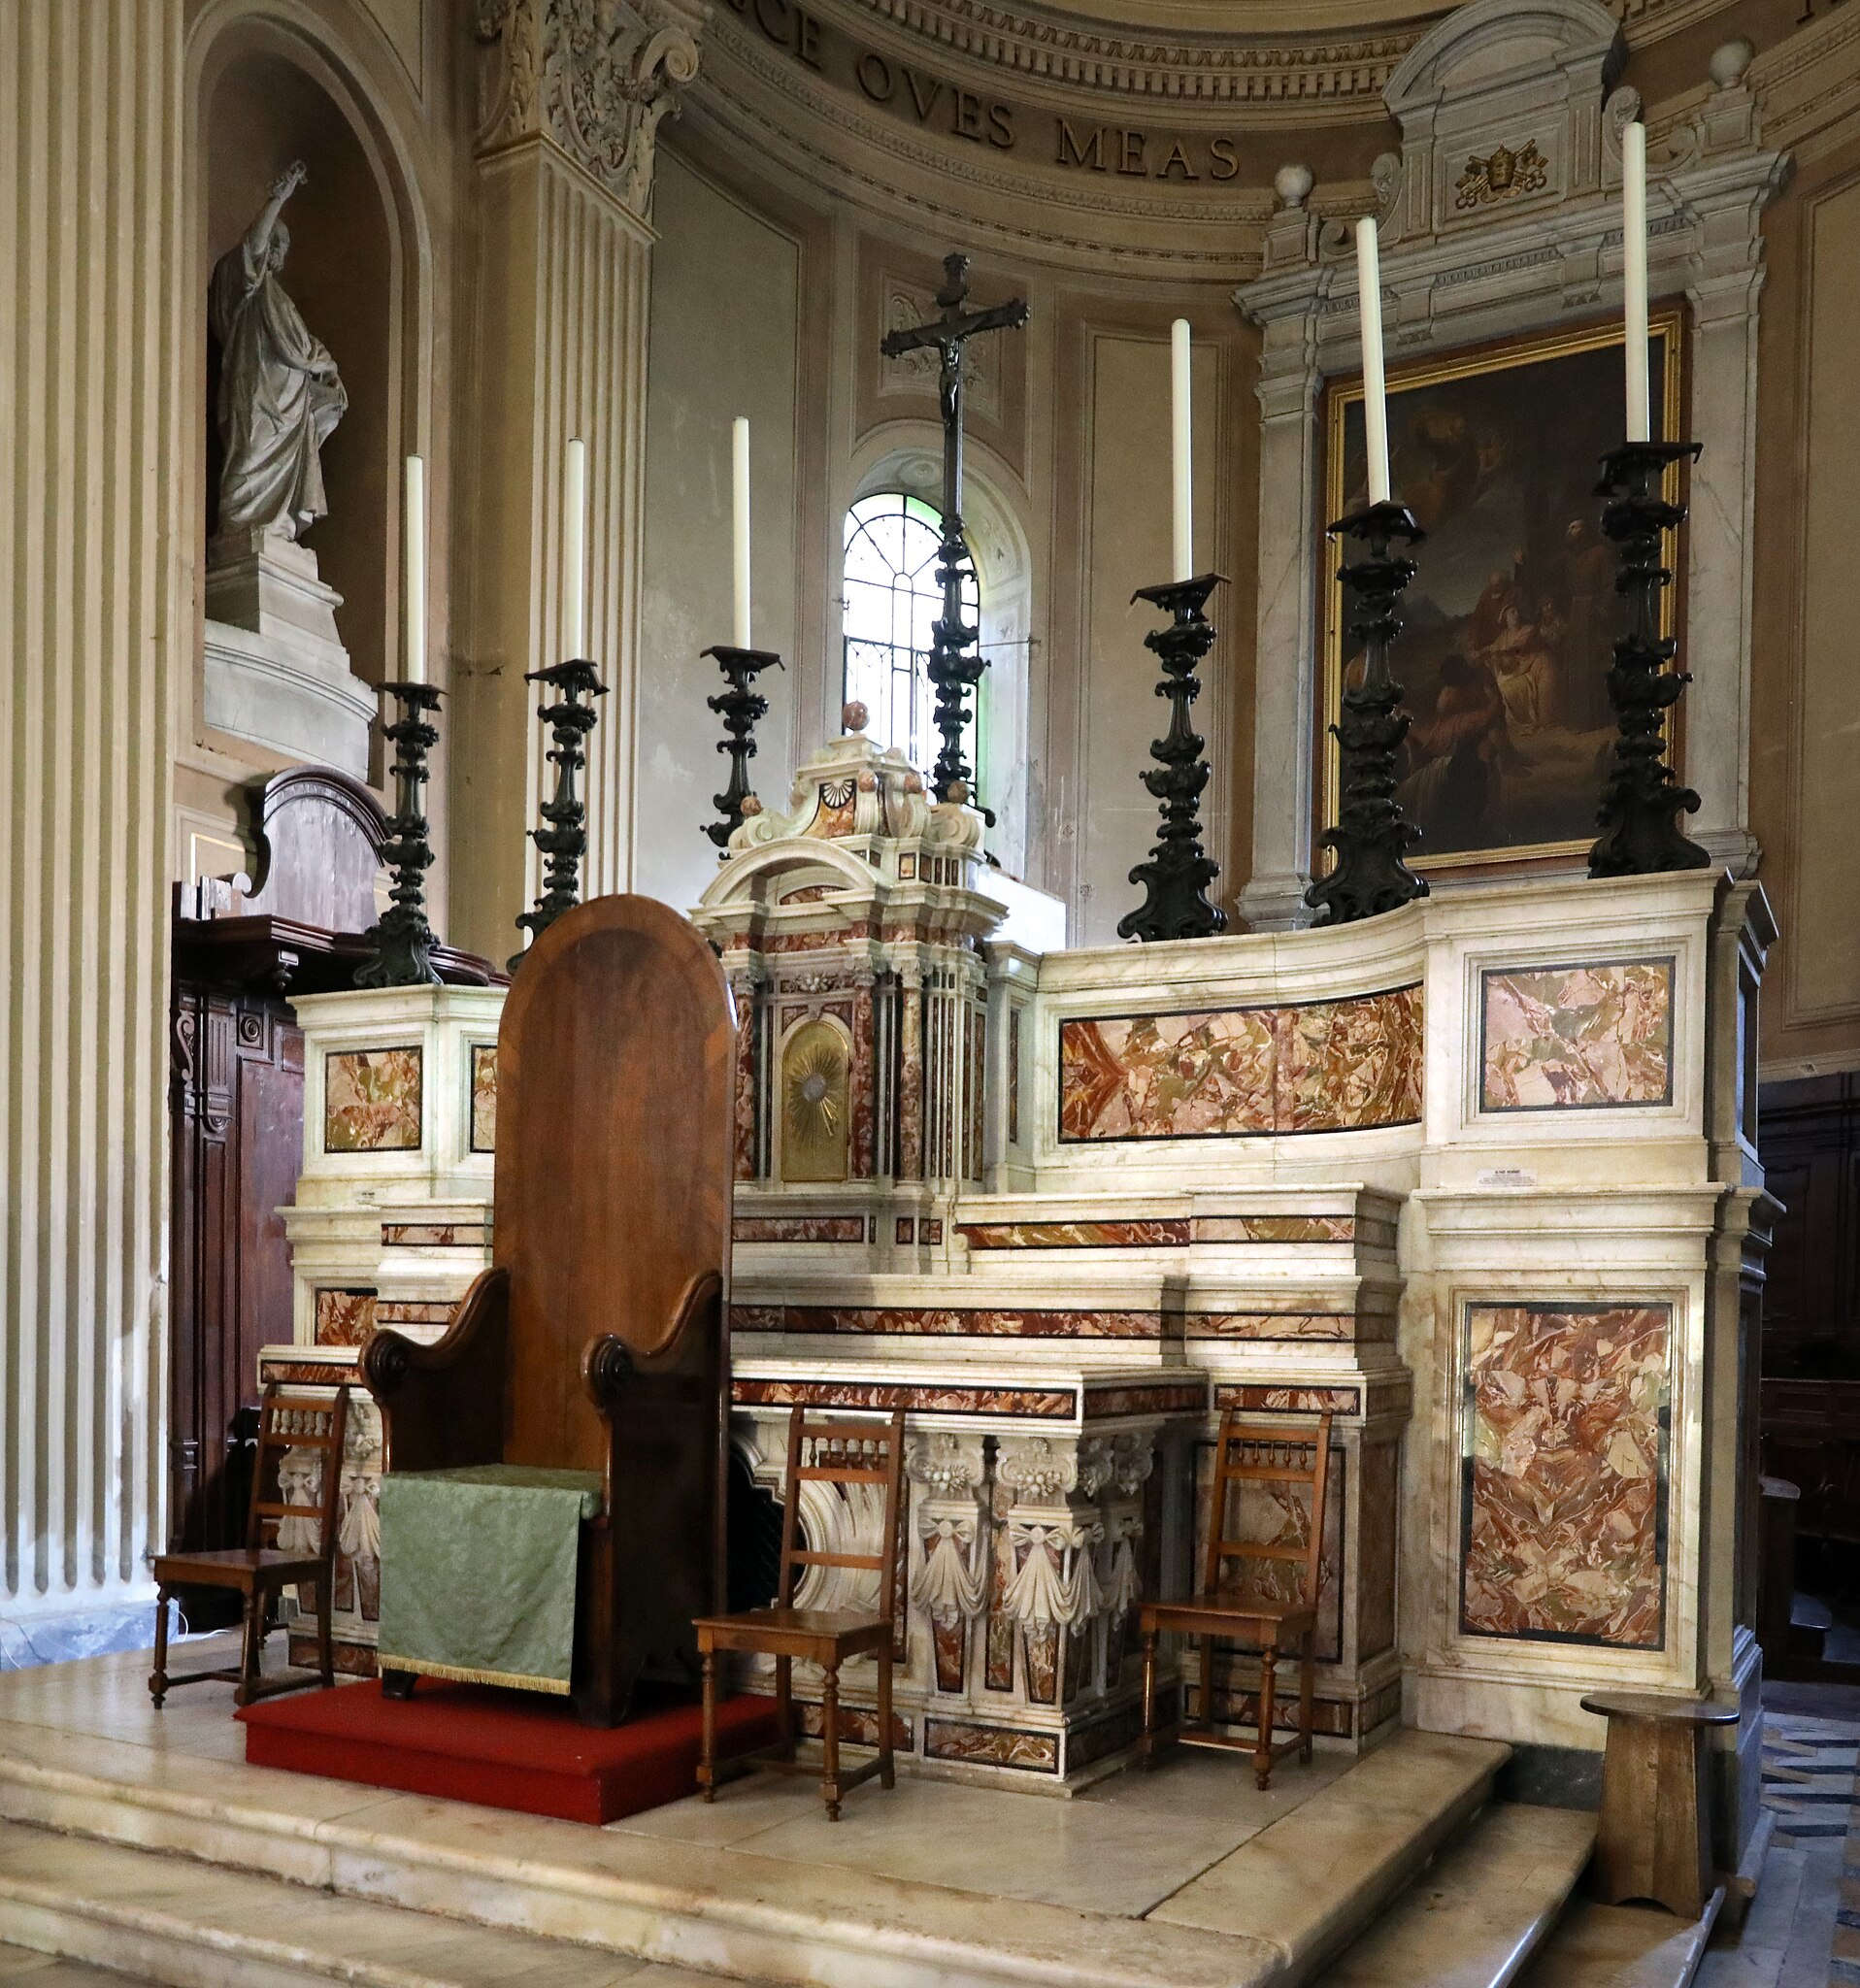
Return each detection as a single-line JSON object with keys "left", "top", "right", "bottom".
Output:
{"left": 362, "top": 1267, "right": 511, "bottom": 1472}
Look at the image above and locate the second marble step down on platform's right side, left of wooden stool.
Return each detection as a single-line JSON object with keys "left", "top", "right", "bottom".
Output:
{"left": 1317, "top": 1801, "right": 1596, "bottom": 1988}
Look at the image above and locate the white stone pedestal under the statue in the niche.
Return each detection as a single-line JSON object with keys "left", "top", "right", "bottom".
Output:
{"left": 205, "top": 531, "right": 376, "bottom": 779}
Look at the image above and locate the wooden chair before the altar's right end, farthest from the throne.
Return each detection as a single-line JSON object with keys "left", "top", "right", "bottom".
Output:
{"left": 1137, "top": 1409, "right": 1331, "bottom": 1789}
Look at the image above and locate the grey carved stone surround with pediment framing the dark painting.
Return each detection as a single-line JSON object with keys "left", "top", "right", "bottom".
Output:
{"left": 1234, "top": 0, "right": 1786, "bottom": 928}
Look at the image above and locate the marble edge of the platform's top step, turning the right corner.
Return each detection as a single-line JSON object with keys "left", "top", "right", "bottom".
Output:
{"left": 0, "top": 1724, "right": 1511, "bottom": 1988}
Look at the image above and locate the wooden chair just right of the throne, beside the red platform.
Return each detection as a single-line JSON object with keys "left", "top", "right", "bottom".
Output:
{"left": 698, "top": 1408, "right": 904, "bottom": 1823}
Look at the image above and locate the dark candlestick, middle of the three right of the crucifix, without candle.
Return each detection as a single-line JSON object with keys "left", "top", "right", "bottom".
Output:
{"left": 1306, "top": 499, "right": 1427, "bottom": 924}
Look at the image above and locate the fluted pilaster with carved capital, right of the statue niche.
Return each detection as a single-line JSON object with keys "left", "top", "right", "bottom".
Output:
{"left": 449, "top": 0, "right": 702, "bottom": 958}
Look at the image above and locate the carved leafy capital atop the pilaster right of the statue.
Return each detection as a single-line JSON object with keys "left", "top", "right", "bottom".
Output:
{"left": 475, "top": 0, "right": 702, "bottom": 215}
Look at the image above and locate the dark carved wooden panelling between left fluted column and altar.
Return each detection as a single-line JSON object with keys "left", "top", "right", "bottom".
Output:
{"left": 169, "top": 980, "right": 304, "bottom": 1552}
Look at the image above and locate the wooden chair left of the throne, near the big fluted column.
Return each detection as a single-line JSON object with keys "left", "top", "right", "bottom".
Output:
{"left": 149, "top": 1381, "right": 348, "bottom": 1711}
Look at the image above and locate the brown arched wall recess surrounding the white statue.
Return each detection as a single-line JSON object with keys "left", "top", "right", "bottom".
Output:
{"left": 191, "top": 4, "right": 423, "bottom": 739}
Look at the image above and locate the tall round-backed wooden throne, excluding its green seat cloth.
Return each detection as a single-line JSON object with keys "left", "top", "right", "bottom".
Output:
{"left": 362, "top": 897, "right": 735, "bottom": 1726}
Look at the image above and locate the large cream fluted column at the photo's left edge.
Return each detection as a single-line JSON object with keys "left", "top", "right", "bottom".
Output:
{"left": 0, "top": 0, "right": 184, "bottom": 1622}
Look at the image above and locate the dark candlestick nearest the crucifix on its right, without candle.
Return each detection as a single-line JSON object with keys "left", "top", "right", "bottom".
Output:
{"left": 1116, "top": 573, "right": 1226, "bottom": 941}
